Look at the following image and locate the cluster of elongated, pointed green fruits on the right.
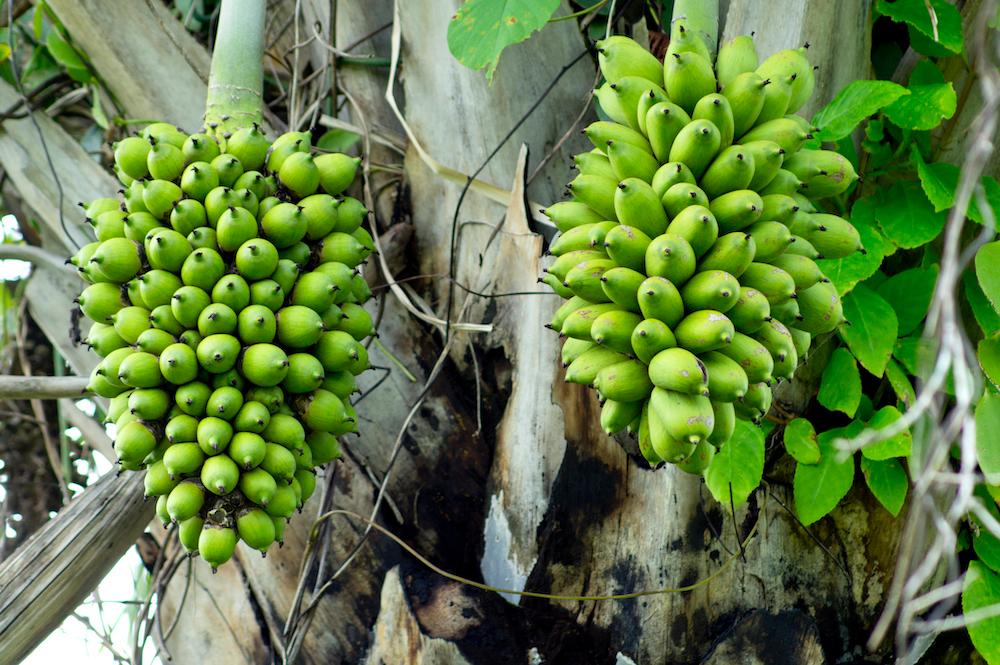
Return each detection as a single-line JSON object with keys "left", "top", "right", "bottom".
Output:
{"left": 541, "top": 28, "right": 863, "bottom": 473}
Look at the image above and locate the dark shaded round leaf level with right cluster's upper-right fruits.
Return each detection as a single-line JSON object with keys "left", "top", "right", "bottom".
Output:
{"left": 875, "top": 180, "right": 947, "bottom": 249}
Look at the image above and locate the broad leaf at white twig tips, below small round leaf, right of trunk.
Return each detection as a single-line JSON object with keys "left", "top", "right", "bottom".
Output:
{"left": 792, "top": 428, "right": 854, "bottom": 526}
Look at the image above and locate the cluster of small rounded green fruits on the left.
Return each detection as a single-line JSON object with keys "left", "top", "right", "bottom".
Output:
{"left": 71, "top": 123, "right": 374, "bottom": 570}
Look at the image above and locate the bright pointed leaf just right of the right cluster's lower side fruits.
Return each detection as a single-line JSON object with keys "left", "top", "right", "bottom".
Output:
{"left": 840, "top": 284, "right": 899, "bottom": 376}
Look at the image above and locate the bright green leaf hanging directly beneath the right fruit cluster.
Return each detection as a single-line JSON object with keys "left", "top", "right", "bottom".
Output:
{"left": 705, "top": 420, "right": 764, "bottom": 508}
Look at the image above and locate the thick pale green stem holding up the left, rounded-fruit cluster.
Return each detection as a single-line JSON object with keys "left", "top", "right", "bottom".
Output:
{"left": 205, "top": 0, "right": 267, "bottom": 133}
